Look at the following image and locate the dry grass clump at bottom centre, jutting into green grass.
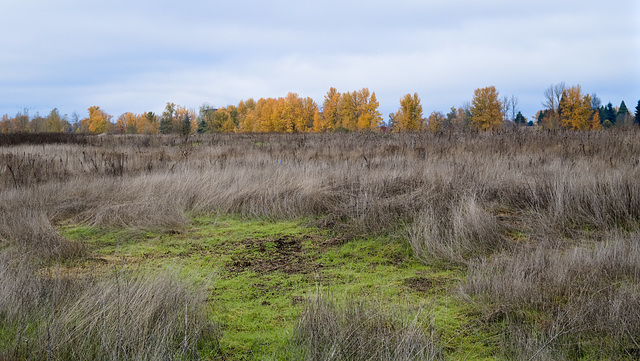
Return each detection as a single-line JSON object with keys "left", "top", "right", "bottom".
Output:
{"left": 292, "top": 296, "right": 444, "bottom": 360}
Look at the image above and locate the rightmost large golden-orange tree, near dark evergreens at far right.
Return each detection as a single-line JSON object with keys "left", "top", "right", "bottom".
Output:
{"left": 558, "top": 85, "right": 592, "bottom": 130}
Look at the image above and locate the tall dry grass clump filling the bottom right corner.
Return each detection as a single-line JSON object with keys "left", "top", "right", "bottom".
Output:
{"left": 463, "top": 232, "right": 640, "bottom": 357}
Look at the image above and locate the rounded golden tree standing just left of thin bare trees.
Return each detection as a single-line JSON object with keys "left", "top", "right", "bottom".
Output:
{"left": 471, "top": 86, "right": 503, "bottom": 131}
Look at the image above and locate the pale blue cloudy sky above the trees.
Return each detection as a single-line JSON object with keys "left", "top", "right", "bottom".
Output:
{"left": 0, "top": 0, "right": 640, "bottom": 120}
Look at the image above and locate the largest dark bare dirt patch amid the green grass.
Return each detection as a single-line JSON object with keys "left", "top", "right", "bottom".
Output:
{"left": 227, "top": 235, "right": 322, "bottom": 274}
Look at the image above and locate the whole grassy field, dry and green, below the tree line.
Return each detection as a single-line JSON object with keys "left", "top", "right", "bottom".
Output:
{"left": 0, "top": 129, "right": 640, "bottom": 360}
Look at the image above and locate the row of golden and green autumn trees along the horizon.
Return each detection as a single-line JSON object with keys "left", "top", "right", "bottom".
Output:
{"left": 0, "top": 83, "right": 640, "bottom": 135}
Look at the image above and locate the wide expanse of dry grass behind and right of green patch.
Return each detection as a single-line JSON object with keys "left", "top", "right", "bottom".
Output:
{"left": 0, "top": 130, "right": 640, "bottom": 358}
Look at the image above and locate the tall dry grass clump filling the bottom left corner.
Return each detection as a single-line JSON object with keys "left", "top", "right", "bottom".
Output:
{"left": 0, "top": 255, "right": 220, "bottom": 360}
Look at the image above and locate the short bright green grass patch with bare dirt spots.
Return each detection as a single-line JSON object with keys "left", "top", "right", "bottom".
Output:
{"left": 61, "top": 216, "right": 499, "bottom": 360}
